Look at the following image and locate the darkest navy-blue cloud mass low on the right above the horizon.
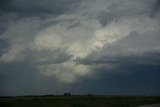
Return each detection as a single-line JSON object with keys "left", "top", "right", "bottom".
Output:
{"left": 67, "top": 63, "right": 160, "bottom": 95}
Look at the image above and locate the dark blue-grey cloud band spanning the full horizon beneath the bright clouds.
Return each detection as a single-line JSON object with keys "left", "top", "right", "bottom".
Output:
{"left": 0, "top": 58, "right": 160, "bottom": 95}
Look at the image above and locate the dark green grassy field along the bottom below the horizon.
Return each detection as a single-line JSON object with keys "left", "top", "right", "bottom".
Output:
{"left": 0, "top": 95, "right": 160, "bottom": 107}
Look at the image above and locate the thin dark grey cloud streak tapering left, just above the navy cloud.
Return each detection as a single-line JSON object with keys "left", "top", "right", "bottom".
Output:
{"left": 78, "top": 51, "right": 160, "bottom": 67}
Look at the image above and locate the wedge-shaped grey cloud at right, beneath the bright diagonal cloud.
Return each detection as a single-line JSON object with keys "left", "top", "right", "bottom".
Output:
{"left": 77, "top": 31, "right": 160, "bottom": 65}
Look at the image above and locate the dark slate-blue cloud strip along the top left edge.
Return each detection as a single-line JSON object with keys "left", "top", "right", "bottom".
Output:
{"left": 0, "top": 0, "right": 81, "bottom": 18}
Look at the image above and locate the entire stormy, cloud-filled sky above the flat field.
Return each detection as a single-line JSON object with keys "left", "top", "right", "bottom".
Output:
{"left": 0, "top": 0, "right": 160, "bottom": 95}
